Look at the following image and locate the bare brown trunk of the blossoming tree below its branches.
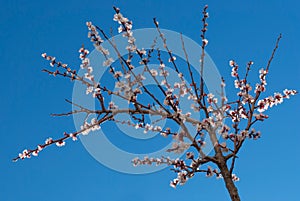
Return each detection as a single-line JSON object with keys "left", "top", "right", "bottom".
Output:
{"left": 218, "top": 157, "right": 241, "bottom": 201}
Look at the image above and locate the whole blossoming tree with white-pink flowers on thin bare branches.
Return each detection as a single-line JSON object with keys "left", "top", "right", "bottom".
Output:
{"left": 13, "top": 6, "right": 297, "bottom": 201}
